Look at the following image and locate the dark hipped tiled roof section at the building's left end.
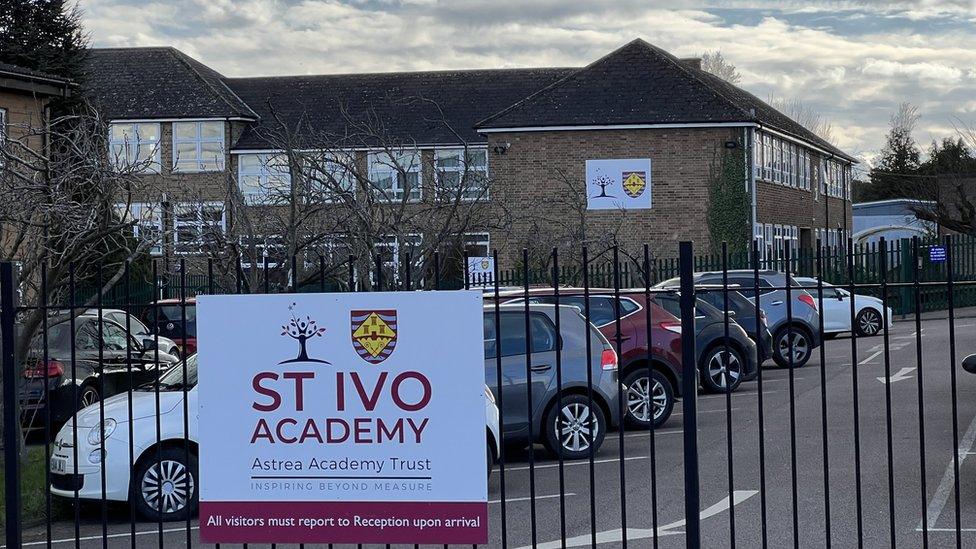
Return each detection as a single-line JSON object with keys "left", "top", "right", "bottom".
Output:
{"left": 87, "top": 47, "right": 256, "bottom": 120}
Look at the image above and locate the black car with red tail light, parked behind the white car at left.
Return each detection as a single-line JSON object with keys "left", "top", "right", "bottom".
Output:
{"left": 20, "top": 314, "right": 178, "bottom": 428}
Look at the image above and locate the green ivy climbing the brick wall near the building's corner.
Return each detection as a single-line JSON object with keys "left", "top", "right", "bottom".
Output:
{"left": 708, "top": 142, "right": 752, "bottom": 253}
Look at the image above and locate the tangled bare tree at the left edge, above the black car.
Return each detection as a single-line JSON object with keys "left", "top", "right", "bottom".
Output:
{"left": 0, "top": 105, "right": 162, "bottom": 452}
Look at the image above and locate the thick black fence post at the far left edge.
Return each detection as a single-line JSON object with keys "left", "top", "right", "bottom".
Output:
{"left": 0, "top": 262, "right": 21, "bottom": 547}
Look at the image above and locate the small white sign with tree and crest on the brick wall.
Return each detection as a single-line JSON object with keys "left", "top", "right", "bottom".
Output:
{"left": 586, "top": 158, "right": 651, "bottom": 210}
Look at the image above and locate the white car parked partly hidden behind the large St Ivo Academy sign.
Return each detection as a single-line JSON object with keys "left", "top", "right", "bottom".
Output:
{"left": 49, "top": 355, "right": 500, "bottom": 521}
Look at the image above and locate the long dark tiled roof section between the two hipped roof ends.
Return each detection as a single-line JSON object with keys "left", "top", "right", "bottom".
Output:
{"left": 227, "top": 68, "right": 575, "bottom": 149}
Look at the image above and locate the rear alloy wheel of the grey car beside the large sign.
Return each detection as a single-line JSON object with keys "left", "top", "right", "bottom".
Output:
{"left": 546, "top": 395, "right": 607, "bottom": 459}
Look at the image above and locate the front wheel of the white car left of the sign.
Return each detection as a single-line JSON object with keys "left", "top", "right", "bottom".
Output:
{"left": 130, "top": 448, "right": 199, "bottom": 521}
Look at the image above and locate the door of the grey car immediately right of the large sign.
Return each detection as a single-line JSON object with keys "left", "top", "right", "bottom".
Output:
{"left": 484, "top": 311, "right": 558, "bottom": 436}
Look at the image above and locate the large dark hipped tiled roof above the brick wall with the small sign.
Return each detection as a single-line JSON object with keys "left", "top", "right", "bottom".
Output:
{"left": 477, "top": 39, "right": 851, "bottom": 159}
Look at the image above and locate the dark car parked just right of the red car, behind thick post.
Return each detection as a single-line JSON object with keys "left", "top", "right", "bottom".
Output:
{"left": 654, "top": 292, "right": 759, "bottom": 393}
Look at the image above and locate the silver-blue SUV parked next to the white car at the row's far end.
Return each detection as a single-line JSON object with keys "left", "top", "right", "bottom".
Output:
{"left": 658, "top": 269, "right": 821, "bottom": 368}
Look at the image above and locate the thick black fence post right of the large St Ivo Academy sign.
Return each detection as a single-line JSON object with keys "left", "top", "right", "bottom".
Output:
{"left": 678, "top": 241, "right": 701, "bottom": 549}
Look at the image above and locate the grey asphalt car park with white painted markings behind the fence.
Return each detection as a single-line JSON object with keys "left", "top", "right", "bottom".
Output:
{"left": 11, "top": 311, "right": 976, "bottom": 547}
